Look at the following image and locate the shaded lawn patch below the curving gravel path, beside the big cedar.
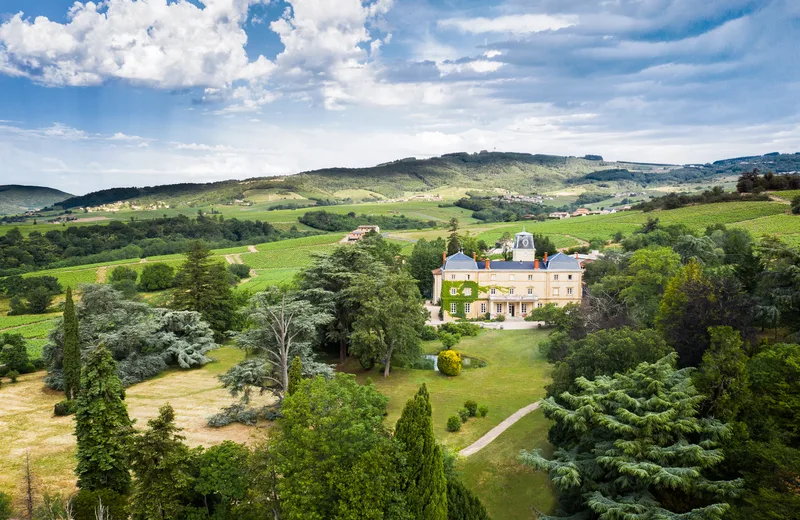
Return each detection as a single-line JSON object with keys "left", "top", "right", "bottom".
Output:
{"left": 456, "top": 410, "right": 557, "bottom": 520}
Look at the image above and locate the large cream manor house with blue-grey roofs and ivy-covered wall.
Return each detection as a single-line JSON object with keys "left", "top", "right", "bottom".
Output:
{"left": 433, "top": 231, "right": 583, "bottom": 318}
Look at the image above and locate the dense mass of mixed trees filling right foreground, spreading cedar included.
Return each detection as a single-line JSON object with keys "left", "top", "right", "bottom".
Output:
{"left": 521, "top": 219, "right": 800, "bottom": 520}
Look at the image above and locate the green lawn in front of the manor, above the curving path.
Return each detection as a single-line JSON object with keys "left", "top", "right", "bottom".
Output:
{"left": 344, "top": 330, "right": 550, "bottom": 450}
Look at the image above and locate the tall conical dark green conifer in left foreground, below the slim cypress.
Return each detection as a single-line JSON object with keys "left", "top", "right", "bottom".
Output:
{"left": 75, "top": 345, "right": 133, "bottom": 494}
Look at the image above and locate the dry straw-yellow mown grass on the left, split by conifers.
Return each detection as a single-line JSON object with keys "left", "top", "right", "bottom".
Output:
{"left": 0, "top": 347, "right": 269, "bottom": 497}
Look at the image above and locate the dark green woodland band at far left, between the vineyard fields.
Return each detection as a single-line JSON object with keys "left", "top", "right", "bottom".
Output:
{"left": 0, "top": 214, "right": 307, "bottom": 275}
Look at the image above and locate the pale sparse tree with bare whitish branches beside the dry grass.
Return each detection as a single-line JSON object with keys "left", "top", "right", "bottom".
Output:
{"left": 220, "top": 288, "right": 333, "bottom": 404}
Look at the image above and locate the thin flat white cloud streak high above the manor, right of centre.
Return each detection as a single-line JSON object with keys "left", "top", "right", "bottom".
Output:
{"left": 438, "top": 14, "right": 578, "bottom": 34}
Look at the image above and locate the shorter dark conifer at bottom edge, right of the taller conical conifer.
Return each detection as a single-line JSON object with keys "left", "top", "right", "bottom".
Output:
{"left": 131, "top": 404, "right": 193, "bottom": 520}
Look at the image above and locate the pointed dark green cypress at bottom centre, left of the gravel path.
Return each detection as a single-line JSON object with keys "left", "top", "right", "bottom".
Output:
{"left": 394, "top": 384, "right": 447, "bottom": 520}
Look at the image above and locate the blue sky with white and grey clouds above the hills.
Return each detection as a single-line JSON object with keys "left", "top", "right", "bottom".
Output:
{"left": 0, "top": 0, "right": 800, "bottom": 194}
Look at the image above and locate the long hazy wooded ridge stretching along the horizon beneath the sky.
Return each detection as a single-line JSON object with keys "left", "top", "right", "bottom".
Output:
{"left": 31, "top": 151, "right": 800, "bottom": 209}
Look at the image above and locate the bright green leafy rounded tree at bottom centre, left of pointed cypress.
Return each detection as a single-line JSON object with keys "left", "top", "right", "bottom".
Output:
{"left": 272, "top": 374, "right": 411, "bottom": 520}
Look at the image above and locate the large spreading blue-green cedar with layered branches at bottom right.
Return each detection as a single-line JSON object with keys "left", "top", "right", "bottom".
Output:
{"left": 521, "top": 354, "right": 741, "bottom": 520}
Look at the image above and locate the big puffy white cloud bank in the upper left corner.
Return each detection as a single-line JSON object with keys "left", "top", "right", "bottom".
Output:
{"left": 0, "top": 0, "right": 274, "bottom": 88}
